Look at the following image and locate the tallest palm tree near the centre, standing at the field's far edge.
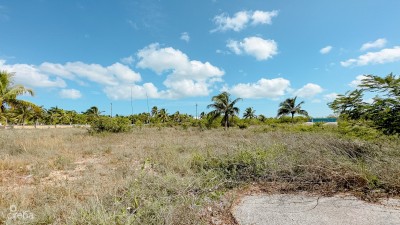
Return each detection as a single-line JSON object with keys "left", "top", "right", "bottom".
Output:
{"left": 207, "top": 91, "right": 242, "bottom": 130}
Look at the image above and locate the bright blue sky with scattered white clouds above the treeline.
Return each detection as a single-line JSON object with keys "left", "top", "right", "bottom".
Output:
{"left": 0, "top": 0, "right": 400, "bottom": 117}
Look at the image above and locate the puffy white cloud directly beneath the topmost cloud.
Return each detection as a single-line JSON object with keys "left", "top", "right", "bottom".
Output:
{"left": 226, "top": 37, "right": 278, "bottom": 61}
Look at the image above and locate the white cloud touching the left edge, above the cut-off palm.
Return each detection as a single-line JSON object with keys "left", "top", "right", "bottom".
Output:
{"left": 0, "top": 60, "right": 67, "bottom": 88}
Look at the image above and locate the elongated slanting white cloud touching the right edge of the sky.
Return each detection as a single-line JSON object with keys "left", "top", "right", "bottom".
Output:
{"left": 340, "top": 46, "right": 400, "bottom": 67}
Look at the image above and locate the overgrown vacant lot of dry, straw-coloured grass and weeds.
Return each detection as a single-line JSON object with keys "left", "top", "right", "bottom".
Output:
{"left": 0, "top": 126, "right": 400, "bottom": 224}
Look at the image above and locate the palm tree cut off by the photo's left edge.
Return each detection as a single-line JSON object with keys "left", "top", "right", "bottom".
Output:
{"left": 0, "top": 71, "right": 36, "bottom": 125}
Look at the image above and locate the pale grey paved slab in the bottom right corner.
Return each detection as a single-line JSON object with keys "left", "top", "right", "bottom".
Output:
{"left": 232, "top": 194, "right": 400, "bottom": 225}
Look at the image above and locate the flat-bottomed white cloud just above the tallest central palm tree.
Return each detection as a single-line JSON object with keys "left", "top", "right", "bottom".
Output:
{"left": 226, "top": 78, "right": 290, "bottom": 99}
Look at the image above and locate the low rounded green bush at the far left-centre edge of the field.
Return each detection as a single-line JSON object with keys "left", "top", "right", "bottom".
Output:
{"left": 89, "top": 117, "right": 132, "bottom": 133}
